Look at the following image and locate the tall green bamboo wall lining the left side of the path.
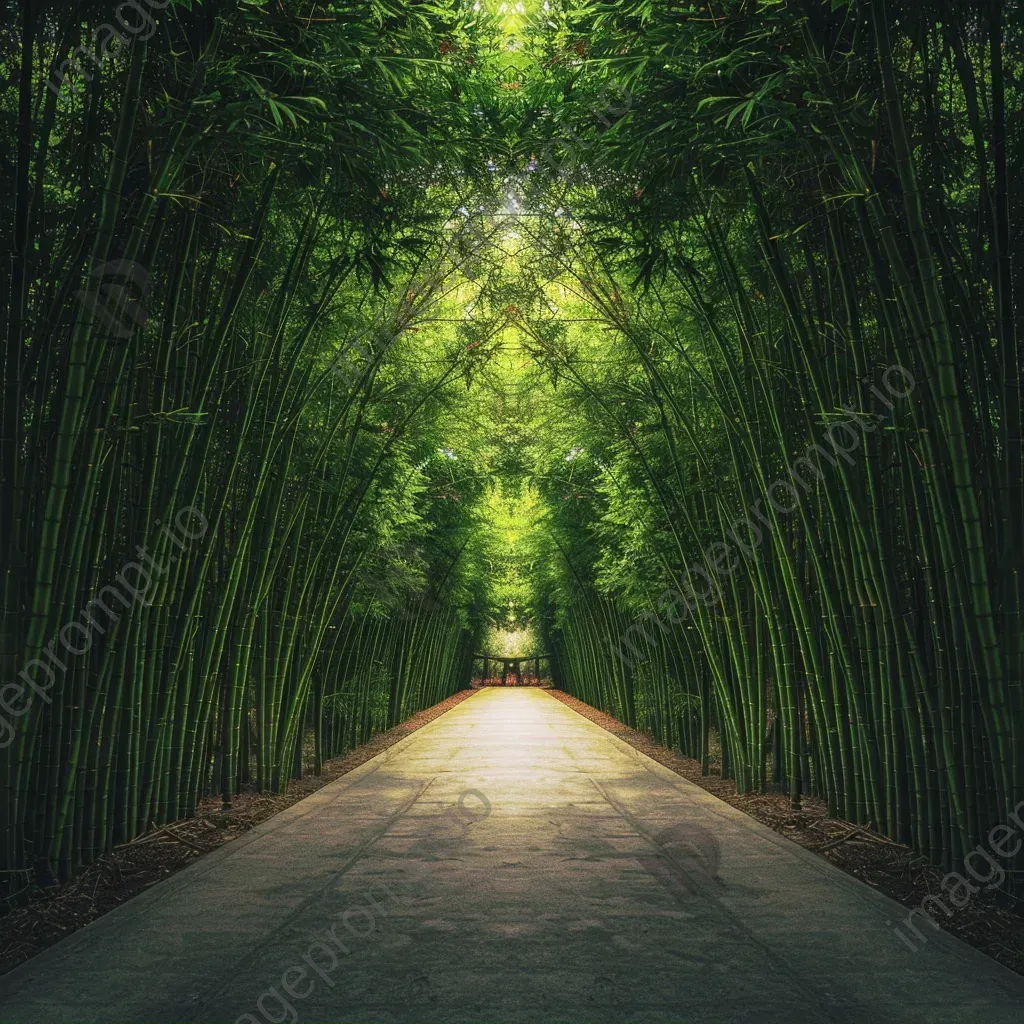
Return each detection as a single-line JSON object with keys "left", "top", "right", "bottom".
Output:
{"left": 0, "top": 0, "right": 495, "bottom": 894}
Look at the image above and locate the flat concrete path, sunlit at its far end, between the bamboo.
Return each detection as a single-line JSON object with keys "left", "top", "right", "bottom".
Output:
{"left": 0, "top": 689, "right": 1024, "bottom": 1024}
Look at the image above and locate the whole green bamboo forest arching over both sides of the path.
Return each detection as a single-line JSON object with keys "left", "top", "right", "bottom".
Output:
{"left": 0, "top": 0, "right": 1024, "bottom": 1021}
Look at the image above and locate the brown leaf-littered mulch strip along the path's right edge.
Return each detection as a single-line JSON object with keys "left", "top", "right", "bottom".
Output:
{"left": 550, "top": 690, "right": 1024, "bottom": 975}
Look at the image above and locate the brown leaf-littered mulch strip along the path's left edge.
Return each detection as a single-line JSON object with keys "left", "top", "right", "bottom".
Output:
{"left": 0, "top": 689, "right": 476, "bottom": 974}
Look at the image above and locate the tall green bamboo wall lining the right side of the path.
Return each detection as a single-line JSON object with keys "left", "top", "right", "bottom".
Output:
{"left": 538, "top": 0, "right": 1024, "bottom": 880}
